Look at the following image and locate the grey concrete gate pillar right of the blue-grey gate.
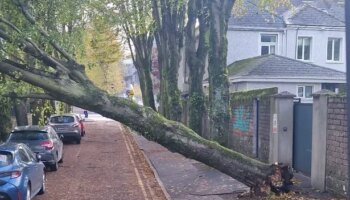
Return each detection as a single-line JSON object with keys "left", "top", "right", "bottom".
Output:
{"left": 311, "top": 90, "right": 334, "bottom": 191}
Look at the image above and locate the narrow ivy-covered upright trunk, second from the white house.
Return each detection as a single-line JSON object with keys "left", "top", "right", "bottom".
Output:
{"left": 185, "top": 0, "right": 209, "bottom": 135}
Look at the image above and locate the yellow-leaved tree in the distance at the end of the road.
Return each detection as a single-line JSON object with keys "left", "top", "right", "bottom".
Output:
{"left": 77, "top": 18, "right": 124, "bottom": 94}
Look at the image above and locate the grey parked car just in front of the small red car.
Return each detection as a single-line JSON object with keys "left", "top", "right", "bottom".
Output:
{"left": 49, "top": 114, "right": 81, "bottom": 144}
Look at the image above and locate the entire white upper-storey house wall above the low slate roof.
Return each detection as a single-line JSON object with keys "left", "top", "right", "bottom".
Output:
{"left": 227, "top": 27, "right": 345, "bottom": 72}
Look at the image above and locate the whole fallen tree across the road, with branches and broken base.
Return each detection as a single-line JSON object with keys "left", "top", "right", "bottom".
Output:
{"left": 0, "top": 0, "right": 289, "bottom": 194}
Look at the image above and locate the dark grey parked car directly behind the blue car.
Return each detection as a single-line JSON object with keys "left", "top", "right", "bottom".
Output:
{"left": 7, "top": 126, "right": 63, "bottom": 171}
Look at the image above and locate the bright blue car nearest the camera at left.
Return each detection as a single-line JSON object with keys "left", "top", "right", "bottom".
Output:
{"left": 0, "top": 143, "right": 45, "bottom": 200}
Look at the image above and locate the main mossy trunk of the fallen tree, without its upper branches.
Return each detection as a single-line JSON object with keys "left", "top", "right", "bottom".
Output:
{"left": 0, "top": 59, "right": 290, "bottom": 187}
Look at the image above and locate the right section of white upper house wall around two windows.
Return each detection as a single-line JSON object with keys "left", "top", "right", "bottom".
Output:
{"left": 282, "top": 27, "right": 346, "bottom": 72}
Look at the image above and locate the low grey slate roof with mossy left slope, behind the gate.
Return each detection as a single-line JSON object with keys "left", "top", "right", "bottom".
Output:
{"left": 228, "top": 55, "right": 345, "bottom": 80}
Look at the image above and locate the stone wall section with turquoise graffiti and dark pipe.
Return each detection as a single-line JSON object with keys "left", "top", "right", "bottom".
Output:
{"left": 229, "top": 88, "right": 277, "bottom": 163}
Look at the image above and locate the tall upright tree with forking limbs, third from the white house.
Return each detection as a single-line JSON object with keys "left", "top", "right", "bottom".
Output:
{"left": 152, "top": 0, "right": 187, "bottom": 121}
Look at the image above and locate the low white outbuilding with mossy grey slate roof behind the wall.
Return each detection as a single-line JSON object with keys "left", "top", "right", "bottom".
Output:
{"left": 224, "top": 54, "right": 346, "bottom": 103}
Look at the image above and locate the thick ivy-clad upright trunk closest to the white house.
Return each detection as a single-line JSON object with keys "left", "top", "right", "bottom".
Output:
{"left": 208, "top": 0, "right": 234, "bottom": 145}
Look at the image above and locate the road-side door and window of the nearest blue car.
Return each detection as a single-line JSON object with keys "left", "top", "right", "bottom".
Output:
{"left": 18, "top": 147, "right": 42, "bottom": 192}
